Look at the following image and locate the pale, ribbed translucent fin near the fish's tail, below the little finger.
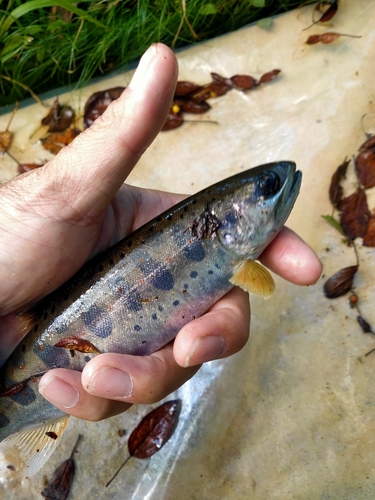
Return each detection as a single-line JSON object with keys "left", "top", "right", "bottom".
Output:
{"left": 3, "top": 415, "right": 69, "bottom": 477}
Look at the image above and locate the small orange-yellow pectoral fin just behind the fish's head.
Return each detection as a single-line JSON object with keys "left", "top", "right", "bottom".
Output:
{"left": 230, "top": 260, "right": 275, "bottom": 299}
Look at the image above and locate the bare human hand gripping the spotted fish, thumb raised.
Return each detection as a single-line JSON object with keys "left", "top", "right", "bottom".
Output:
{"left": 0, "top": 44, "right": 322, "bottom": 420}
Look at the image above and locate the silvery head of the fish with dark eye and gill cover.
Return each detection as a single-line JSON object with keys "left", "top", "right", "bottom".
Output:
{"left": 214, "top": 161, "right": 302, "bottom": 259}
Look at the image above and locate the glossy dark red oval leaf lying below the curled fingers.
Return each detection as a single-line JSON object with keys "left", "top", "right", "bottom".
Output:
{"left": 128, "top": 399, "right": 181, "bottom": 458}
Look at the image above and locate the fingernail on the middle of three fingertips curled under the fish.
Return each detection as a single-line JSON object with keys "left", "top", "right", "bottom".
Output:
{"left": 85, "top": 366, "right": 133, "bottom": 399}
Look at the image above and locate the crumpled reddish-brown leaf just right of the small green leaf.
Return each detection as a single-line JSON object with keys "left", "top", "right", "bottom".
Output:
{"left": 337, "top": 189, "right": 370, "bottom": 240}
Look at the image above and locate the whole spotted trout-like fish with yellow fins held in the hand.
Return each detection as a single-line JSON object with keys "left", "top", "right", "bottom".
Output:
{"left": 0, "top": 161, "right": 302, "bottom": 476}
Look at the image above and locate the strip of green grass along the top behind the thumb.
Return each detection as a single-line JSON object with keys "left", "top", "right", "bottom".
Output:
{"left": 0, "top": 0, "right": 300, "bottom": 106}
